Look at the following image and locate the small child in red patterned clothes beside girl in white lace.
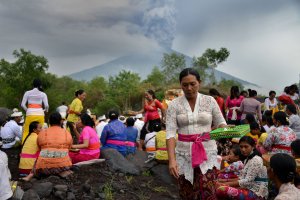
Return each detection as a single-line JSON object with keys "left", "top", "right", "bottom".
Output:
{"left": 218, "top": 145, "right": 244, "bottom": 182}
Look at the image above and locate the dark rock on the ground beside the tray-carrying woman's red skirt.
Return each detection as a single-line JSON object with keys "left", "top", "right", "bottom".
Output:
{"left": 150, "top": 164, "right": 177, "bottom": 185}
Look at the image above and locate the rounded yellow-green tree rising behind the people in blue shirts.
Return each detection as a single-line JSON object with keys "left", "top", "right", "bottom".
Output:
{"left": 109, "top": 70, "right": 141, "bottom": 111}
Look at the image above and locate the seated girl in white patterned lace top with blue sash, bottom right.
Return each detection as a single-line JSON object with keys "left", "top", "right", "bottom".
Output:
{"left": 216, "top": 136, "right": 268, "bottom": 200}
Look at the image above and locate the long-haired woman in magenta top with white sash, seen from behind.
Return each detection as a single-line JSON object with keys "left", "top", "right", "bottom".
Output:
{"left": 225, "top": 86, "right": 244, "bottom": 125}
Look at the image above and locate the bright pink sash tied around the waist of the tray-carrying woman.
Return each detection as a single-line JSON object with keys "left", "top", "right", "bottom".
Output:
{"left": 178, "top": 132, "right": 210, "bottom": 168}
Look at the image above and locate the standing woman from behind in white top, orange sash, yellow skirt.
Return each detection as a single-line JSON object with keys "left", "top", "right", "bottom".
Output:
{"left": 21, "top": 79, "right": 49, "bottom": 143}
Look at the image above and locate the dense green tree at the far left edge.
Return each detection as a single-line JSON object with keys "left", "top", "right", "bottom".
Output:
{"left": 0, "top": 49, "right": 50, "bottom": 108}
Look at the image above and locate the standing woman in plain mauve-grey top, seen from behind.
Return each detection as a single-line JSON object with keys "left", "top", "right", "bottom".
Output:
{"left": 239, "top": 89, "right": 262, "bottom": 124}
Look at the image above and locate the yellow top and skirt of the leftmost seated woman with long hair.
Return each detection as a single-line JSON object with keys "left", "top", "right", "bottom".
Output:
{"left": 19, "top": 133, "right": 39, "bottom": 169}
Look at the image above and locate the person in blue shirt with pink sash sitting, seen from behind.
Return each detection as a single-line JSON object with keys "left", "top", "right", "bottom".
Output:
{"left": 100, "top": 110, "right": 127, "bottom": 156}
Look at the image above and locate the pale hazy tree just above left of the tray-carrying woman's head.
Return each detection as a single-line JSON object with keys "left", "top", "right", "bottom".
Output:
{"left": 162, "top": 52, "right": 186, "bottom": 84}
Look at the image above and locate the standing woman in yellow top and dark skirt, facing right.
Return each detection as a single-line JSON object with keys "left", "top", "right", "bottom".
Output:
{"left": 67, "top": 90, "right": 86, "bottom": 144}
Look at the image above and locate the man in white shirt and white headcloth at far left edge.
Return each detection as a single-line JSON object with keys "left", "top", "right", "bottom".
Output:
{"left": 0, "top": 112, "right": 22, "bottom": 149}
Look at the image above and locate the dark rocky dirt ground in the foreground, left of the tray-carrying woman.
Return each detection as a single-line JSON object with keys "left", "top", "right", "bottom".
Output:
{"left": 7, "top": 147, "right": 179, "bottom": 200}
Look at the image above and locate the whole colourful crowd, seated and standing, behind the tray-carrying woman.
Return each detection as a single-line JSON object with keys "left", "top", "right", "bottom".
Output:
{"left": 0, "top": 77, "right": 300, "bottom": 200}
